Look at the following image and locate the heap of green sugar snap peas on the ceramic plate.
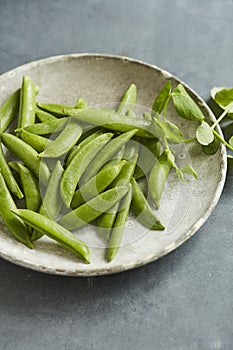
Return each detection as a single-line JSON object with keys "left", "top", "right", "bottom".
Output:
{"left": 0, "top": 76, "right": 205, "bottom": 263}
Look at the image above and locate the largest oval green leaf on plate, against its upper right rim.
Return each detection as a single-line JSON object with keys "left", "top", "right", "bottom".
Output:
{"left": 171, "top": 84, "right": 205, "bottom": 120}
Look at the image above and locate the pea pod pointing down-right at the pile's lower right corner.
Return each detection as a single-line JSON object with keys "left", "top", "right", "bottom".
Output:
{"left": 131, "top": 177, "right": 165, "bottom": 230}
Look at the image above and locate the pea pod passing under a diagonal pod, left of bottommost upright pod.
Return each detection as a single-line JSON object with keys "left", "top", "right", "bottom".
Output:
{"left": 97, "top": 146, "right": 138, "bottom": 239}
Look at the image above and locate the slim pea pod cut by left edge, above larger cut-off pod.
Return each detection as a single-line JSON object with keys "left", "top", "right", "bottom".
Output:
{"left": 0, "top": 143, "right": 23, "bottom": 198}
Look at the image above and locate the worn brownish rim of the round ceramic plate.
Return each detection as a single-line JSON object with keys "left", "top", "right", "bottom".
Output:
{"left": 0, "top": 53, "right": 227, "bottom": 277}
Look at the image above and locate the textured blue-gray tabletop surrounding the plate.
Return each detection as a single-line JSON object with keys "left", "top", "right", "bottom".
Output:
{"left": 0, "top": 0, "right": 233, "bottom": 350}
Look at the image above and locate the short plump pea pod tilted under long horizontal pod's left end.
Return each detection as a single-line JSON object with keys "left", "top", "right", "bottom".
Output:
{"left": 39, "top": 118, "right": 82, "bottom": 158}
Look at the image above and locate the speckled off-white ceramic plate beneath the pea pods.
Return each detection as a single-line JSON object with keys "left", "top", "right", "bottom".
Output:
{"left": 0, "top": 54, "right": 227, "bottom": 276}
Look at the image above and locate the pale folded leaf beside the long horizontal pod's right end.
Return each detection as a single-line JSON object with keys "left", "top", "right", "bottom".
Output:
{"left": 153, "top": 118, "right": 183, "bottom": 143}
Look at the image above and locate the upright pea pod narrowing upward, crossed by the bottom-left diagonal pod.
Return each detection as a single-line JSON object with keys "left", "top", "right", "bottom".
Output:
{"left": 32, "top": 161, "right": 63, "bottom": 241}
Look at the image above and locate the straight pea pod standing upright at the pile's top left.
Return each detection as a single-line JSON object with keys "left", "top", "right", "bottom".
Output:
{"left": 18, "top": 76, "right": 36, "bottom": 128}
